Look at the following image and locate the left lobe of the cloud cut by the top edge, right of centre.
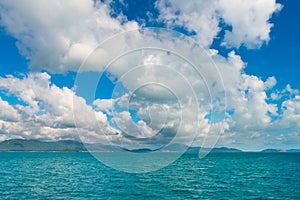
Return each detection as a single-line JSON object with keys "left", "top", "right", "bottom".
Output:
{"left": 156, "top": 0, "right": 220, "bottom": 47}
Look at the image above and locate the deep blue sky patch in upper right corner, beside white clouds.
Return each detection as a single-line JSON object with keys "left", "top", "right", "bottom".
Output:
{"left": 241, "top": 1, "right": 300, "bottom": 88}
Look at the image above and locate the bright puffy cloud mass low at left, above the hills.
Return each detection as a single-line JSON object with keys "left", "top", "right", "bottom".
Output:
{"left": 0, "top": 73, "right": 118, "bottom": 141}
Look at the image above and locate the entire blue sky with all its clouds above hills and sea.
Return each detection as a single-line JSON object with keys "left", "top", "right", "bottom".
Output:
{"left": 0, "top": 0, "right": 300, "bottom": 150}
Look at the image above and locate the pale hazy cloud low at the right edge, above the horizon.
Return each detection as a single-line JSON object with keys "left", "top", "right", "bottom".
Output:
{"left": 219, "top": 84, "right": 300, "bottom": 150}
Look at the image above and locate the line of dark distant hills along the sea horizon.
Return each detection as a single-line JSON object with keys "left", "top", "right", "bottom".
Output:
{"left": 0, "top": 139, "right": 300, "bottom": 153}
